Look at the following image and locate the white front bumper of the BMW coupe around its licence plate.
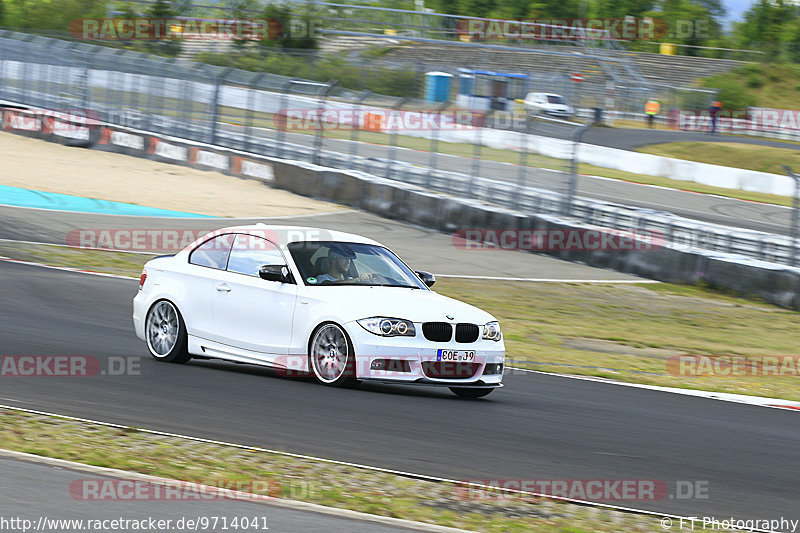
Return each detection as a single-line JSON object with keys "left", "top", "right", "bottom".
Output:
{"left": 345, "top": 322, "right": 505, "bottom": 388}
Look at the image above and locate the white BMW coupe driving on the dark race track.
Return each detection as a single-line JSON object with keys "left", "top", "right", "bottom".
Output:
{"left": 133, "top": 224, "right": 505, "bottom": 398}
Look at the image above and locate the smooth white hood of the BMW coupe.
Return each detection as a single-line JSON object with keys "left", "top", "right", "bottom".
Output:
{"left": 301, "top": 285, "right": 495, "bottom": 324}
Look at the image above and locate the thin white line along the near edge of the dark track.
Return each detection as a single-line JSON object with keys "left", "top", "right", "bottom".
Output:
{"left": 0, "top": 404, "right": 766, "bottom": 531}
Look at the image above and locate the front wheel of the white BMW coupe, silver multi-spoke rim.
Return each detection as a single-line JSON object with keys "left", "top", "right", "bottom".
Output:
{"left": 308, "top": 322, "right": 357, "bottom": 387}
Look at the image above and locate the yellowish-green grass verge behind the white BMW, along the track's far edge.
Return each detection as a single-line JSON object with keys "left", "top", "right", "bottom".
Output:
{"left": 6, "top": 243, "right": 800, "bottom": 401}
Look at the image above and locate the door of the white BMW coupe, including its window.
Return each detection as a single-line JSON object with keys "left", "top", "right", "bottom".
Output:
{"left": 214, "top": 234, "right": 297, "bottom": 360}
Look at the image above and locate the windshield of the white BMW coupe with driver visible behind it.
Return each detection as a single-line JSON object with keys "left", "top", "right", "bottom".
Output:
{"left": 288, "top": 241, "right": 427, "bottom": 289}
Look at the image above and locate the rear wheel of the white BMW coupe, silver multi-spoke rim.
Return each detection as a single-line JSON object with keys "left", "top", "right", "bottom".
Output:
{"left": 144, "top": 300, "right": 192, "bottom": 363}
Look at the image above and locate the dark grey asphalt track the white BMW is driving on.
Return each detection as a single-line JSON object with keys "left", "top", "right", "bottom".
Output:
{"left": 0, "top": 263, "right": 800, "bottom": 519}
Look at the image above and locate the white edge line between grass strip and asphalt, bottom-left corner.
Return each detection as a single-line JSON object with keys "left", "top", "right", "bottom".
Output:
{"left": 0, "top": 448, "right": 470, "bottom": 533}
